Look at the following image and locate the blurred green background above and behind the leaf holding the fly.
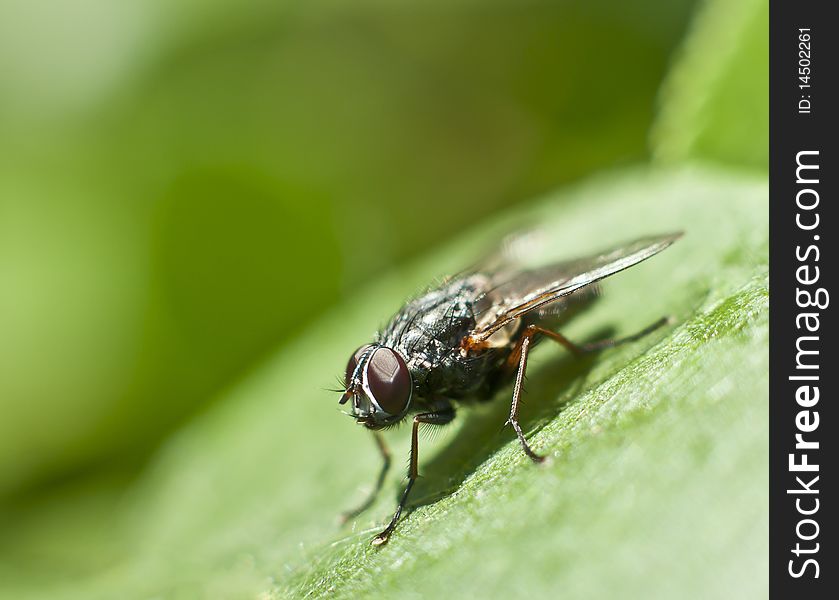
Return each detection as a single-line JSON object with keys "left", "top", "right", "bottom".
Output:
{"left": 0, "top": 0, "right": 768, "bottom": 593}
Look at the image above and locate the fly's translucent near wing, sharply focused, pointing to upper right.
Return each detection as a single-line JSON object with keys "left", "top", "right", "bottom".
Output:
{"left": 469, "top": 232, "right": 682, "bottom": 344}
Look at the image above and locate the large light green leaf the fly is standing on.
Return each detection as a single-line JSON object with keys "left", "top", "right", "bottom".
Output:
{"left": 0, "top": 169, "right": 768, "bottom": 598}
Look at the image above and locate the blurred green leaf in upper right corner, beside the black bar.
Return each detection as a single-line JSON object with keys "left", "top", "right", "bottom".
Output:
{"left": 651, "top": 0, "right": 772, "bottom": 171}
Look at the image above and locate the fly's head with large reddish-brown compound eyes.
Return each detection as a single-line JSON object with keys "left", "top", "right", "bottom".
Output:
{"left": 340, "top": 344, "right": 414, "bottom": 429}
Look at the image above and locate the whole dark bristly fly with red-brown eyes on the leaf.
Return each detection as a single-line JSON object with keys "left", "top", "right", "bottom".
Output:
{"left": 340, "top": 233, "right": 682, "bottom": 545}
